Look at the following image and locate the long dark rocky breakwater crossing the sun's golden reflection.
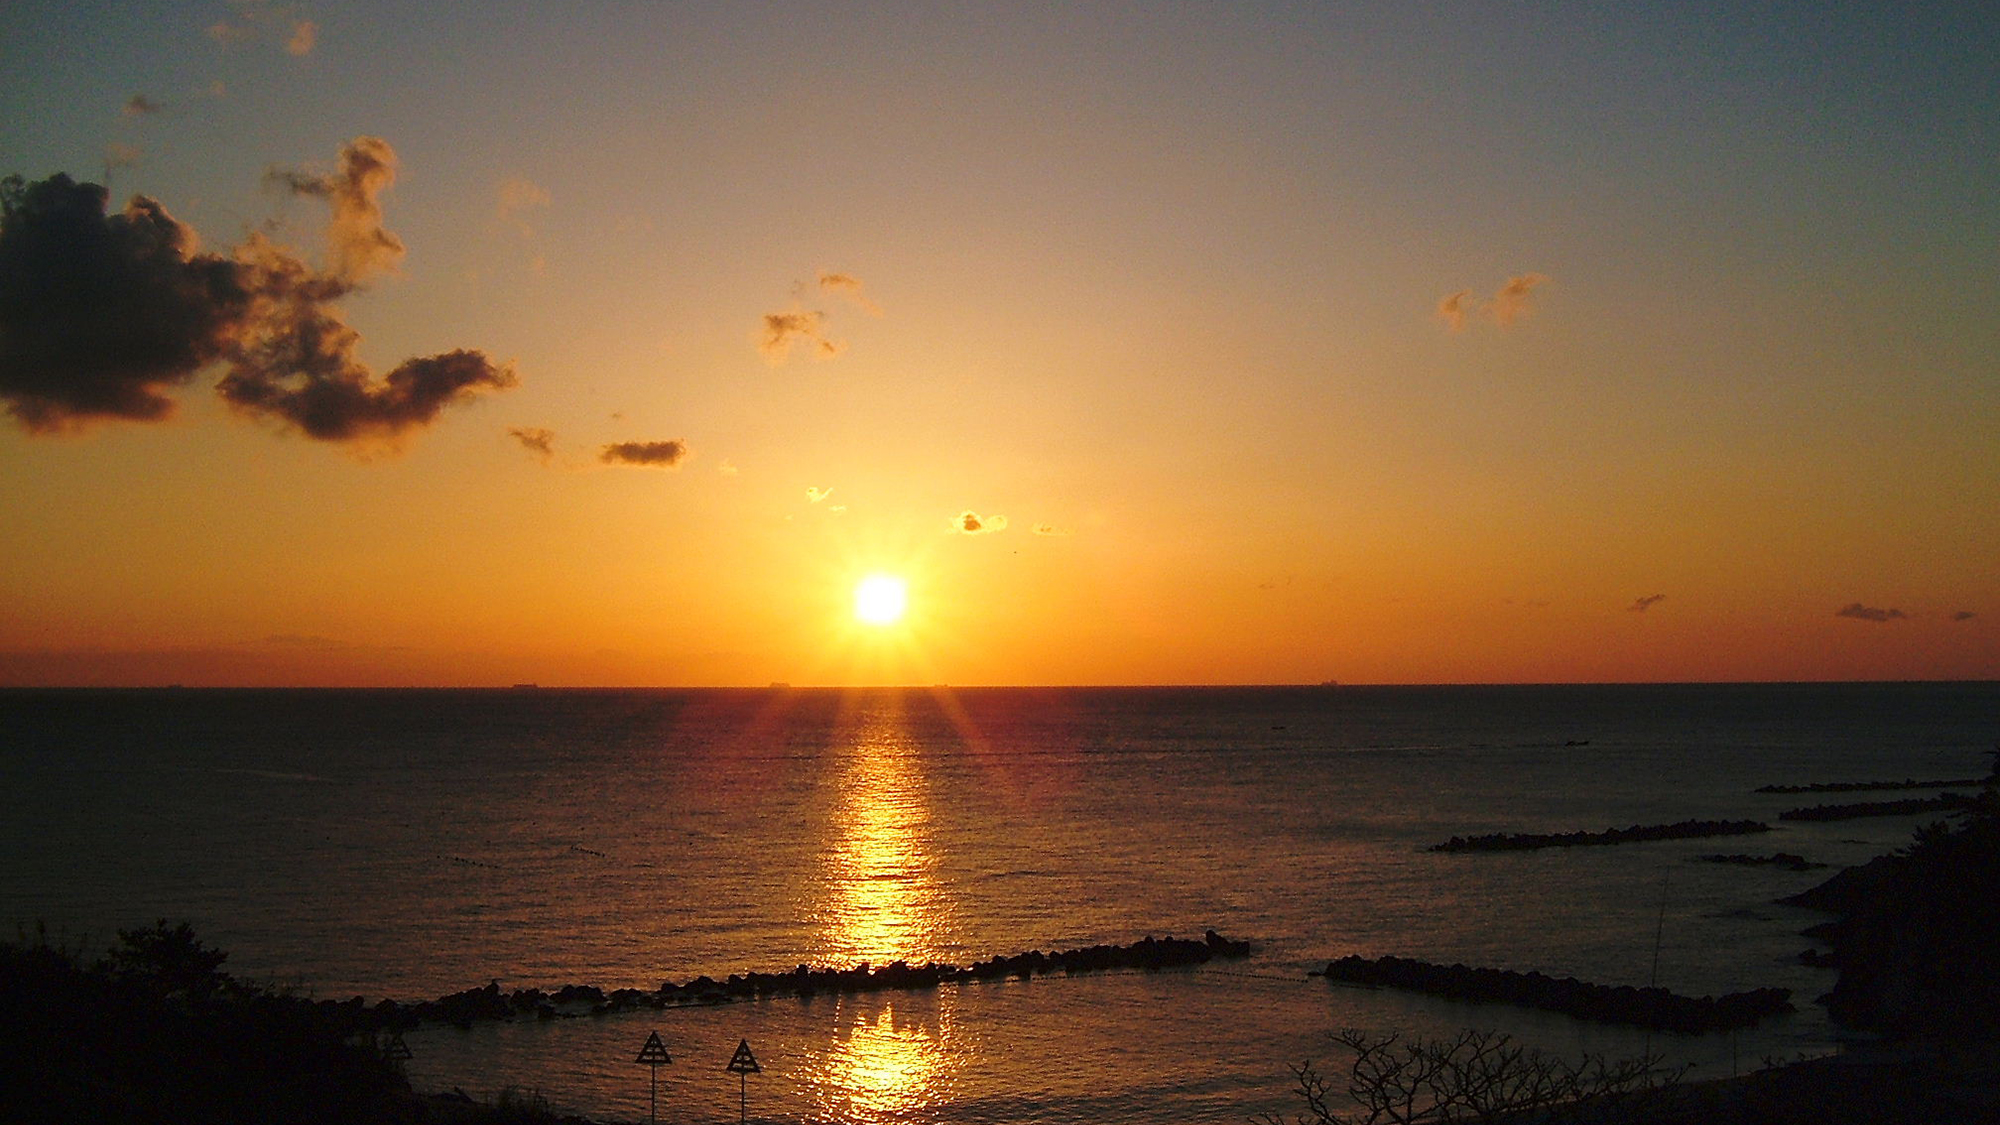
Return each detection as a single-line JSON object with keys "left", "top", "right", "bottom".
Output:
{"left": 360, "top": 931, "right": 1250, "bottom": 1027}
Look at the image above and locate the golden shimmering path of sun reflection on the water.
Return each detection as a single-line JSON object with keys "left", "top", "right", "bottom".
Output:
{"left": 798, "top": 693, "right": 966, "bottom": 1121}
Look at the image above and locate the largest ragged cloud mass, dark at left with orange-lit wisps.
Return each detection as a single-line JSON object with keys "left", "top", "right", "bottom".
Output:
{"left": 0, "top": 136, "right": 516, "bottom": 442}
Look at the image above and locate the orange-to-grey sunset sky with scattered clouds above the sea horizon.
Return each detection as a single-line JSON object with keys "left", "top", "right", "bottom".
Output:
{"left": 0, "top": 0, "right": 2000, "bottom": 687}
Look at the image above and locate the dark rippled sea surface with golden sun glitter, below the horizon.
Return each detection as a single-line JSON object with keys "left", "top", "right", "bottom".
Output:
{"left": 0, "top": 685, "right": 2000, "bottom": 1123}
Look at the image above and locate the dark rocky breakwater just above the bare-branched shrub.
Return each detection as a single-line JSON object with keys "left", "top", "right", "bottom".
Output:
{"left": 1318, "top": 957, "right": 1792, "bottom": 1035}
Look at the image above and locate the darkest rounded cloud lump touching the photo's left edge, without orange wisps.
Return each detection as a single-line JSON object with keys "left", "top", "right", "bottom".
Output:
{"left": 0, "top": 174, "right": 252, "bottom": 432}
